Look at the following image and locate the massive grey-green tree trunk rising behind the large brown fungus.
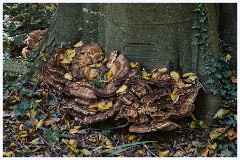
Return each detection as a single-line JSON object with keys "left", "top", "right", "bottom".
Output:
{"left": 41, "top": 3, "right": 234, "bottom": 125}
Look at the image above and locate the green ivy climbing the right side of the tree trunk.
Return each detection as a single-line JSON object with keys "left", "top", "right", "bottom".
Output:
{"left": 192, "top": 4, "right": 237, "bottom": 156}
